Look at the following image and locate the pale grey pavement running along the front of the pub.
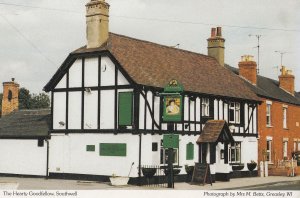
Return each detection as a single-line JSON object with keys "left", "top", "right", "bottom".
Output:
{"left": 0, "top": 176, "right": 300, "bottom": 190}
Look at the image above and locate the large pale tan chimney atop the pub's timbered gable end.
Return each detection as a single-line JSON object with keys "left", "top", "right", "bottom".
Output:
{"left": 86, "top": 0, "right": 109, "bottom": 48}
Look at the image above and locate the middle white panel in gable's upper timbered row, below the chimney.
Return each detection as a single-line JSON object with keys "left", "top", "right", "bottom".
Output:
{"left": 84, "top": 58, "right": 99, "bottom": 87}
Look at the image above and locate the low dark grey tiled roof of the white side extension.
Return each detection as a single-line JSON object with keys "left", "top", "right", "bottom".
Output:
{"left": 0, "top": 109, "right": 51, "bottom": 138}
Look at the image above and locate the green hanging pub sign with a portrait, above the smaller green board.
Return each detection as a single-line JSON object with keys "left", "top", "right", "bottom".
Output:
{"left": 162, "top": 80, "right": 183, "bottom": 122}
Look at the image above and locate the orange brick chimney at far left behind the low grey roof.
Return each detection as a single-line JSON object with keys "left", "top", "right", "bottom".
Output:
{"left": 2, "top": 78, "right": 19, "bottom": 116}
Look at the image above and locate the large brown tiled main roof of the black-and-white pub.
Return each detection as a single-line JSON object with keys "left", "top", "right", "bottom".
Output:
{"left": 44, "top": 33, "right": 259, "bottom": 100}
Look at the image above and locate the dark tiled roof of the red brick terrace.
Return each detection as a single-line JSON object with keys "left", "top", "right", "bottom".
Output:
{"left": 225, "top": 65, "right": 300, "bottom": 105}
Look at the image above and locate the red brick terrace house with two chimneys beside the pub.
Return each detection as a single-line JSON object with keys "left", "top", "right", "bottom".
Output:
{"left": 227, "top": 56, "right": 300, "bottom": 175}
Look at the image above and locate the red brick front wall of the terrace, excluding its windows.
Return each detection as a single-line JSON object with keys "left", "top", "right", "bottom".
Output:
{"left": 258, "top": 99, "right": 300, "bottom": 163}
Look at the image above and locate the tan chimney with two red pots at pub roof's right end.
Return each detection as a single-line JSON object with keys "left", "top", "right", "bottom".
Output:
{"left": 207, "top": 27, "right": 225, "bottom": 66}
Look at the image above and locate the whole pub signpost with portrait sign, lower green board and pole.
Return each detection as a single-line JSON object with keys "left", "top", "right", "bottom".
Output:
{"left": 162, "top": 80, "right": 183, "bottom": 188}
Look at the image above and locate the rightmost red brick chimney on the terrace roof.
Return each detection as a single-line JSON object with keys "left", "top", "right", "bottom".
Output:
{"left": 279, "top": 66, "right": 295, "bottom": 95}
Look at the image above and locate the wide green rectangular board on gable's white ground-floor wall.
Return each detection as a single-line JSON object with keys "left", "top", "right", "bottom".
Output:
{"left": 99, "top": 143, "right": 126, "bottom": 157}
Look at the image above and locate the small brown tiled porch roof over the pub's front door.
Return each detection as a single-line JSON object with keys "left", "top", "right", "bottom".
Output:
{"left": 197, "top": 120, "right": 234, "bottom": 143}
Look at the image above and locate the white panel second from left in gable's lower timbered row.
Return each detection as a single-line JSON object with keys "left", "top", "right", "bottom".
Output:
{"left": 68, "top": 91, "right": 82, "bottom": 129}
